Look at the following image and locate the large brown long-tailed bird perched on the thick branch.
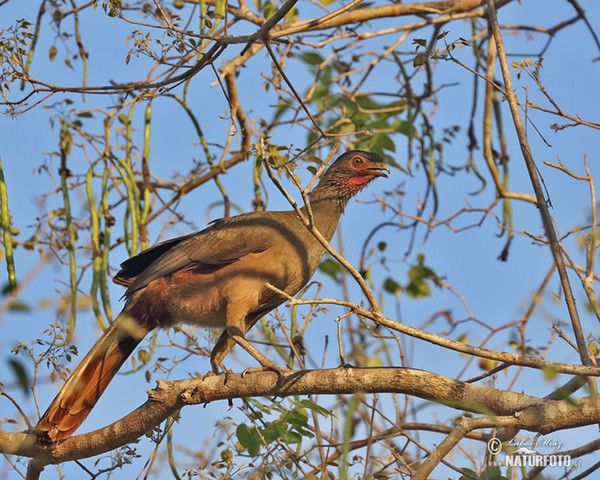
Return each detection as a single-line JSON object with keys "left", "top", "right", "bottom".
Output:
{"left": 35, "top": 150, "right": 390, "bottom": 444}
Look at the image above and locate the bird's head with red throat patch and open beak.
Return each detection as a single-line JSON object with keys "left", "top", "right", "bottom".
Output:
{"left": 310, "top": 150, "right": 390, "bottom": 205}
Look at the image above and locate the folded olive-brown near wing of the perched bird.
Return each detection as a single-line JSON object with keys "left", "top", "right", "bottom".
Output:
{"left": 113, "top": 214, "right": 271, "bottom": 295}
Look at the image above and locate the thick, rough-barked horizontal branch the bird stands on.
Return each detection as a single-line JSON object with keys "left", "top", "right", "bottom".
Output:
{"left": 5, "top": 367, "right": 600, "bottom": 463}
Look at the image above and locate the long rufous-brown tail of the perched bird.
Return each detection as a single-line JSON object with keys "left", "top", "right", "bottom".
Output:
{"left": 35, "top": 312, "right": 148, "bottom": 442}
